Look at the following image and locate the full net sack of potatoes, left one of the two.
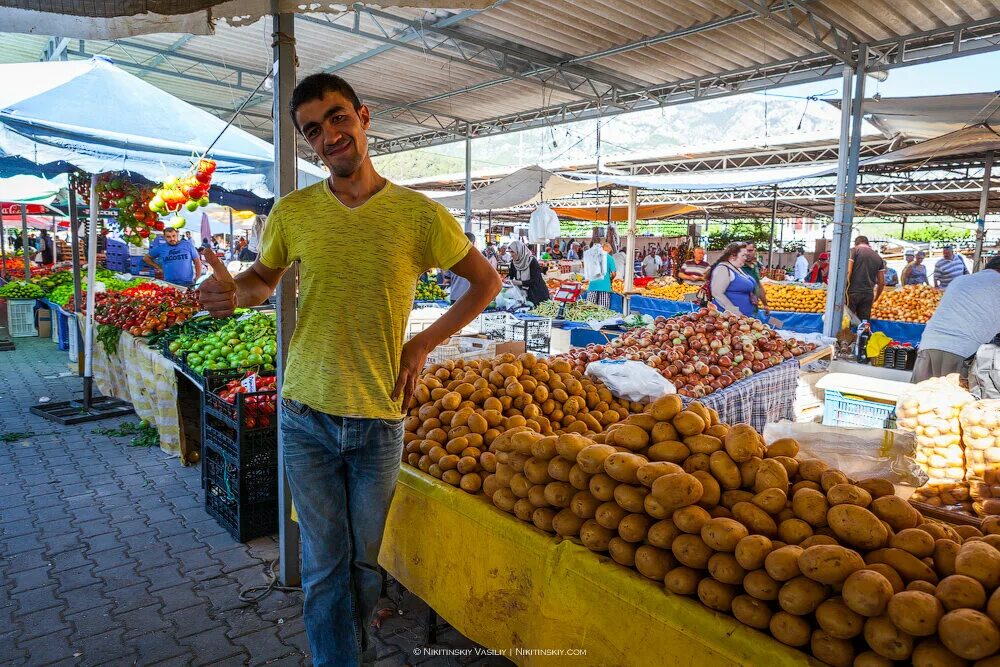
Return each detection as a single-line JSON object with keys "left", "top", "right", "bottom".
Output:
{"left": 896, "top": 376, "right": 973, "bottom": 514}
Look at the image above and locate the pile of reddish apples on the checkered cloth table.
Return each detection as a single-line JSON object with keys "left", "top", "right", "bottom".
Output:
{"left": 562, "top": 308, "right": 816, "bottom": 398}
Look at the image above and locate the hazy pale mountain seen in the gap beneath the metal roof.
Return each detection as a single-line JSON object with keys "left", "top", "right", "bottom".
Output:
{"left": 374, "top": 94, "right": 840, "bottom": 181}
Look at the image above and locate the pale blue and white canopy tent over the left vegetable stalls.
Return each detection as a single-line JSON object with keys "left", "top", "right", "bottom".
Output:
{"left": 0, "top": 58, "right": 326, "bottom": 199}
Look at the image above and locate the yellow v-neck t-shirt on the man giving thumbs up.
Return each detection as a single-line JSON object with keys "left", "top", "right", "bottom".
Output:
{"left": 260, "top": 180, "right": 471, "bottom": 419}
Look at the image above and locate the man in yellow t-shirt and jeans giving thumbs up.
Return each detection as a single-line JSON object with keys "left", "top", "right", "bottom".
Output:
{"left": 200, "top": 74, "right": 501, "bottom": 666}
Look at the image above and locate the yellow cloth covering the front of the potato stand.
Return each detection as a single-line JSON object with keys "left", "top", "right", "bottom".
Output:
{"left": 379, "top": 466, "right": 819, "bottom": 667}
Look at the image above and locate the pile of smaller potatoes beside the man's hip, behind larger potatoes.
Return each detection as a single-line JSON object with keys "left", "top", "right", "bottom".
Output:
{"left": 403, "top": 353, "right": 643, "bottom": 493}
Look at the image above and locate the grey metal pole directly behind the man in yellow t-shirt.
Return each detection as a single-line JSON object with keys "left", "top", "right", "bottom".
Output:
{"left": 271, "top": 6, "right": 302, "bottom": 586}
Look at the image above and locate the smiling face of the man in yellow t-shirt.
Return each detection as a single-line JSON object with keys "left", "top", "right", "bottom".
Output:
{"left": 295, "top": 91, "right": 371, "bottom": 178}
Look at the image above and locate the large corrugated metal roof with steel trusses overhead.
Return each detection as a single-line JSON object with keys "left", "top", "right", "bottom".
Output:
{"left": 0, "top": 0, "right": 1000, "bottom": 162}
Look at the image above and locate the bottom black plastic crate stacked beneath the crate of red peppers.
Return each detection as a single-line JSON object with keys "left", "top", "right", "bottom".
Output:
{"left": 202, "top": 443, "right": 278, "bottom": 542}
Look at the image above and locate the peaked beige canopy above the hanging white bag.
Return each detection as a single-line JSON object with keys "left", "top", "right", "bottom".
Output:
{"left": 428, "top": 165, "right": 596, "bottom": 211}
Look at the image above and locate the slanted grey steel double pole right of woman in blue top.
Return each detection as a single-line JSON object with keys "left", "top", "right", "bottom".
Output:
{"left": 823, "top": 44, "right": 868, "bottom": 337}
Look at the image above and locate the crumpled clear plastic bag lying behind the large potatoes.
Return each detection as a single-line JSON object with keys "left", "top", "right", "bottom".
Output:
{"left": 764, "top": 421, "right": 927, "bottom": 496}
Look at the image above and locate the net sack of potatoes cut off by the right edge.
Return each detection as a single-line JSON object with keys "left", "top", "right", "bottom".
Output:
{"left": 958, "top": 400, "right": 1000, "bottom": 514}
